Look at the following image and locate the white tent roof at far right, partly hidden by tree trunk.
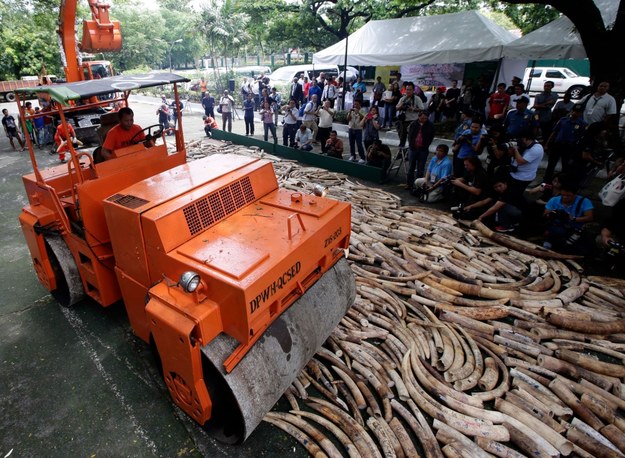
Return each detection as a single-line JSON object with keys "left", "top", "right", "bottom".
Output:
{"left": 503, "top": 0, "right": 620, "bottom": 60}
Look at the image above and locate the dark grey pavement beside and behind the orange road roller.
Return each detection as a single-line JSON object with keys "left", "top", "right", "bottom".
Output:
{"left": 0, "top": 98, "right": 306, "bottom": 457}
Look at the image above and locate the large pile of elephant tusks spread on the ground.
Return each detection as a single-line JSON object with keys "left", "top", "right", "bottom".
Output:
{"left": 188, "top": 143, "right": 625, "bottom": 457}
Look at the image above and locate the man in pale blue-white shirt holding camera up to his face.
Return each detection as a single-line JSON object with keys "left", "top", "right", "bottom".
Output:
{"left": 508, "top": 130, "right": 544, "bottom": 199}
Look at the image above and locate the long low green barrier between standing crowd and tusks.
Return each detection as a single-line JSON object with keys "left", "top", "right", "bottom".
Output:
{"left": 213, "top": 129, "right": 384, "bottom": 183}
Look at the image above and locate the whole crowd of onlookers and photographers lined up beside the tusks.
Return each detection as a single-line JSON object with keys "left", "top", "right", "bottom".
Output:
{"left": 197, "top": 74, "right": 625, "bottom": 264}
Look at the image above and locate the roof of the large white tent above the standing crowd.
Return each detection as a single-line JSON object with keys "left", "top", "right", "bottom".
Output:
{"left": 313, "top": 11, "right": 516, "bottom": 65}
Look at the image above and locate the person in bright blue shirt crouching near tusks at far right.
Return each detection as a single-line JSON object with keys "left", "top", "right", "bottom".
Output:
{"left": 543, "top": 179, "right": 593, "bottom": 255}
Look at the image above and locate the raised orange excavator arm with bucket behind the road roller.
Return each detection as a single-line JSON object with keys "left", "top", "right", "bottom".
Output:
{"left": 58, "top": 0, "right": 122, "bottom": 82}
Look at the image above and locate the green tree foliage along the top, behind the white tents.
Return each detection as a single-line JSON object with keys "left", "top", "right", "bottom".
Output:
{"left": 0, "top": 0, "right": 624, "bottom": 90}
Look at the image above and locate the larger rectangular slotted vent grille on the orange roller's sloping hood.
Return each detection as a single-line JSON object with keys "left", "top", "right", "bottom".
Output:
{"left": 182, "top": 177, "right": 255, "bottom": 235}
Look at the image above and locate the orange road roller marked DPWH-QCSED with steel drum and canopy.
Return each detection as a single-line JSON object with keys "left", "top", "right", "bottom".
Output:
{"left": 17, "top": 74, "right": 355, "bottom": 443}
